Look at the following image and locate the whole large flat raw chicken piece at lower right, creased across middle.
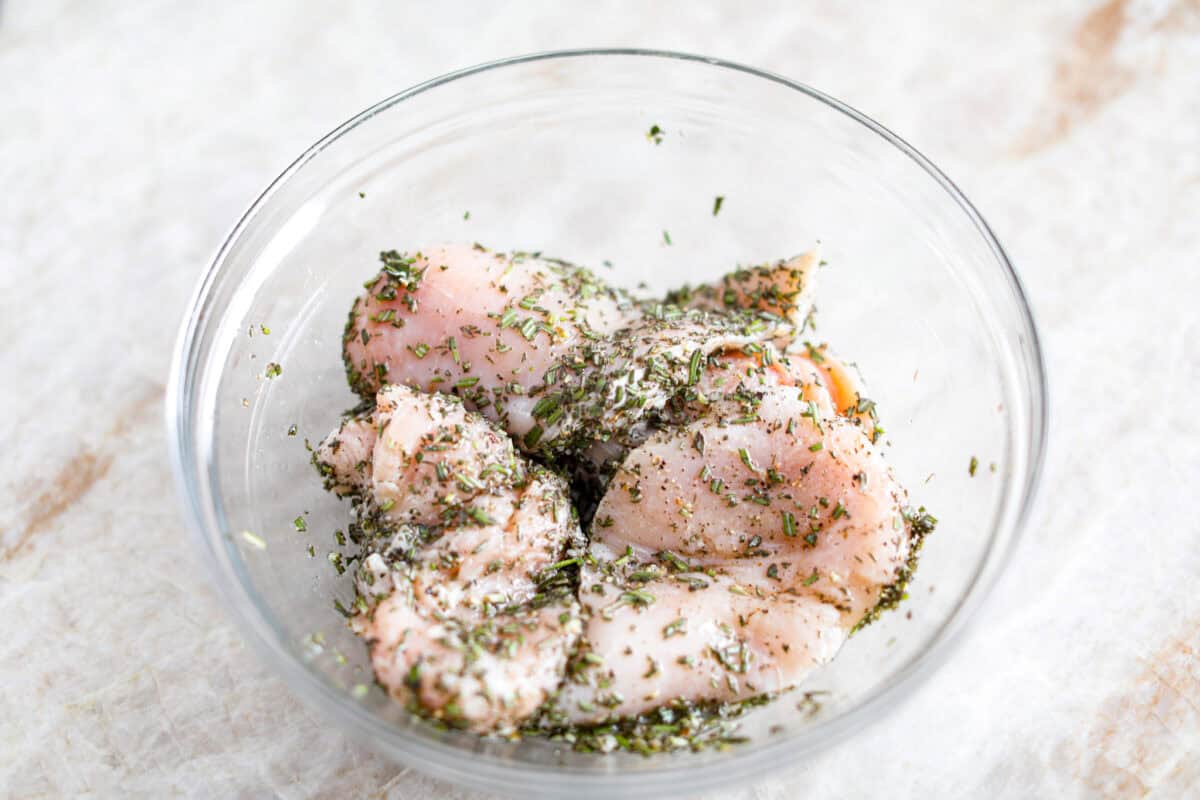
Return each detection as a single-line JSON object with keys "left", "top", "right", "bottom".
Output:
{"left": 558, "top": 385, "right": 920, "bottom": 721}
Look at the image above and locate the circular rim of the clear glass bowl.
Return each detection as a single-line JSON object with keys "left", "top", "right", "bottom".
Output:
{"left": 164, "top": 48, "right": 1049, "bottom": 796}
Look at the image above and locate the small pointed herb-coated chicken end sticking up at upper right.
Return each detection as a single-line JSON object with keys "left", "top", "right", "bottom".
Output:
{"left": 666, "top": 249, "right": 821, "bottom": 329}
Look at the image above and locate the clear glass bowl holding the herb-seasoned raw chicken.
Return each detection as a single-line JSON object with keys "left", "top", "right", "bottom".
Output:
{"left": 167, "top": 50, "right": 1046, "bottom": 798}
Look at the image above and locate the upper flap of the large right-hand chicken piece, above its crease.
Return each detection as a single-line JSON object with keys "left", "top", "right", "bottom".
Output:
{"left": 592, "top": 390, "right": 911, "bottom": 625}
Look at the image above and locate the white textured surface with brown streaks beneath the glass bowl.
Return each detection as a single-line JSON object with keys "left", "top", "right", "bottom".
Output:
{"left": 0, "top": 0, "right": 1200, "bottom": 799}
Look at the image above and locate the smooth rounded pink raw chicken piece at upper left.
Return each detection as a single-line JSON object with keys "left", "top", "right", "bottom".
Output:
{"left": 343, "top": 245, "right": 638, "bottom": 437}
